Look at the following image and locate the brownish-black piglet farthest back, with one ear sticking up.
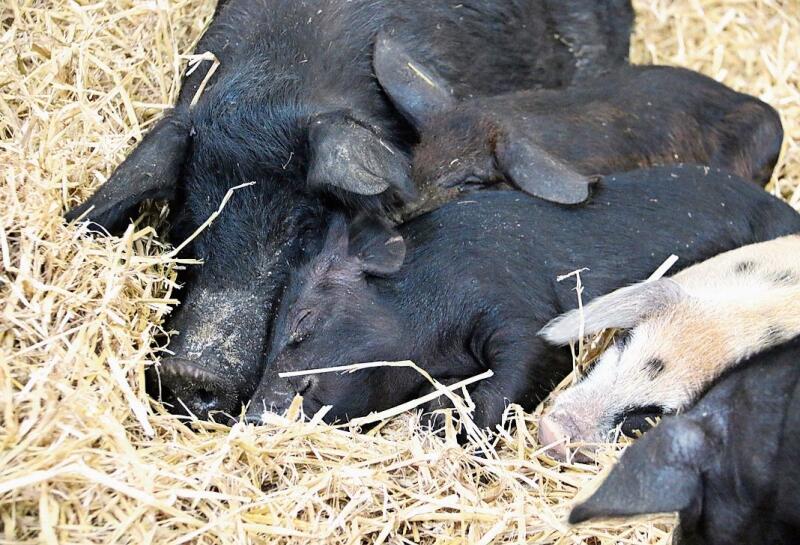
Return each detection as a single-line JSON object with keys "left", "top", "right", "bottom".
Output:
{"left": 375, "top": 51, "right": 783, "bottom": 212}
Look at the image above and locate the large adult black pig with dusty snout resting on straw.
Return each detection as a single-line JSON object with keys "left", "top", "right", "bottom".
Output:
{"left": 67, "top": 0, "right": 632, "bottom": 417}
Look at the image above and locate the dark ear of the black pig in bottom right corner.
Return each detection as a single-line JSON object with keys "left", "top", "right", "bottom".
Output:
{"left": 569, "top": 417, "right": 710, "bottom": 527}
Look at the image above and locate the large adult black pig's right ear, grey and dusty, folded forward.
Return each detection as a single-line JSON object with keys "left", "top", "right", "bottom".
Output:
{"left": 308, "top": 112, "right": 414, "bottom": 200}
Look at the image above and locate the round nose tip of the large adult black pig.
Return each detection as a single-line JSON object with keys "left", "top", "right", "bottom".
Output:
{"left": 155, "top": 358, "right": 240, "bottom": 419}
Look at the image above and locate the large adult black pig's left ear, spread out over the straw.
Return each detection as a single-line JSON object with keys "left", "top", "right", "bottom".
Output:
{"left": 65, "top": 111, "right": 190, "bottom": 232}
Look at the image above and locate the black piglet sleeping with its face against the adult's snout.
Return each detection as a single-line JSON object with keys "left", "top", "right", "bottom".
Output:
{"left": 253, "top": 166, "right": 800, "bottom": 427}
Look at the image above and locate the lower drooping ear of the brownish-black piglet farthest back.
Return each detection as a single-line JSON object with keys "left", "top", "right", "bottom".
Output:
{"left": 495, "top": 127, "right": 598, "bottom": 204}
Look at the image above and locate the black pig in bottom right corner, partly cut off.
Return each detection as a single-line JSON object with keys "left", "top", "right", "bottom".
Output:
{"left": 569, "top": 336, "right": 800, "bottom": 545}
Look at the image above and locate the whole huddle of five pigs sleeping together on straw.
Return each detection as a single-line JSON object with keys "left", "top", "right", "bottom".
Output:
{"left": 67, "top": 0, "right": 800, "bottom": 544}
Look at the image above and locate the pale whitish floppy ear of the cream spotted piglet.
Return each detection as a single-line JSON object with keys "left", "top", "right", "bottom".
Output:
{"left": 539, "top": 278, "right": 687, "bottom": 345}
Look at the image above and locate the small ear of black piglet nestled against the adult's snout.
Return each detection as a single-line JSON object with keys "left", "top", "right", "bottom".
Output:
{"left": 350, "top": 216, "right": 406, "bottom": 276}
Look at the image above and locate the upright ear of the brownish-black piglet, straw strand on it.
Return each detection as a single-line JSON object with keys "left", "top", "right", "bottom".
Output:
{"left": 372, "top": 32, "right": 456, "bottom": 132}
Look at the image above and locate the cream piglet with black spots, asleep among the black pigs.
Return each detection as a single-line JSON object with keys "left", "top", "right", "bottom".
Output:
{"left": 539, "top": 235, "right": 800, "bottom": 458}
